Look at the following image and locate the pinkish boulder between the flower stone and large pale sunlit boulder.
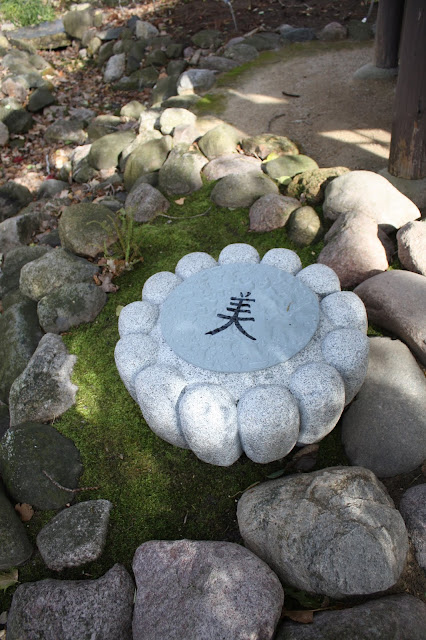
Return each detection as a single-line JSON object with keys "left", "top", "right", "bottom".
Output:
{"left": 318, "top": 213, "right": 394, "bottom": 287}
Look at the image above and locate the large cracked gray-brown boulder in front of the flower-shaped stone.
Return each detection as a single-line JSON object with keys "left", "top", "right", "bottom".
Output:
{"left": 237, "top": 467, "right": 408, "bottom": 598}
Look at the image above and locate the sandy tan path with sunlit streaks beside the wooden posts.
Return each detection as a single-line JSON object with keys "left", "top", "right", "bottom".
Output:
{"left": 221, "top": 45, "right": 396, "bottom": 171}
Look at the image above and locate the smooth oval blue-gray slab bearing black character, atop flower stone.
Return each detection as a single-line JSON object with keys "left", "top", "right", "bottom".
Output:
{"left": 160, "top": 263, "right": 319, "bottom": 373}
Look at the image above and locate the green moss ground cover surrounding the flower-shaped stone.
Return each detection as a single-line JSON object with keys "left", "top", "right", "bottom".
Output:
{"left": 0, "top": 175, "right": 335, "bottom": 611}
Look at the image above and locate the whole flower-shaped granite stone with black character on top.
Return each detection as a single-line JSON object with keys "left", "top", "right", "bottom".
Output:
{"left": 115, "top": 244, "right": 368, "bottom": 466}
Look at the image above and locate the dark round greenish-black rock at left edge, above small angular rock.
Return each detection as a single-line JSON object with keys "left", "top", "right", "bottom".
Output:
{"left": 0, "top": 422, "right": 83, "bottom": 509}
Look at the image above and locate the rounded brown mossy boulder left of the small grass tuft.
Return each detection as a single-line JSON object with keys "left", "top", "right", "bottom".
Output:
{"left": 58, "top": 202, "right": 118, "bottom": 258}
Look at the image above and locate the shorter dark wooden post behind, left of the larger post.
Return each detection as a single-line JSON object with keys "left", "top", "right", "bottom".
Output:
{"left": 374, "top": 0, "right": 404, "bottom": 69}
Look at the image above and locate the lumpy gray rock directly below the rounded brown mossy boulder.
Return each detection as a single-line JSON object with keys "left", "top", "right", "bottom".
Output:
{"left": 19, "top": 248, "right": 99, "bottom": 301}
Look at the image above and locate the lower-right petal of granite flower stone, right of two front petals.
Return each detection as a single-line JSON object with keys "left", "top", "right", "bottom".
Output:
{"left": 289, "top": 362, "right": 345, "bottom": 445}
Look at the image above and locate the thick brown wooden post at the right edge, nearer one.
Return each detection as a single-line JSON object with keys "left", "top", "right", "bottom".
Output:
{"left": 388, "top": 0, "right": 426, "bottom": 180}
